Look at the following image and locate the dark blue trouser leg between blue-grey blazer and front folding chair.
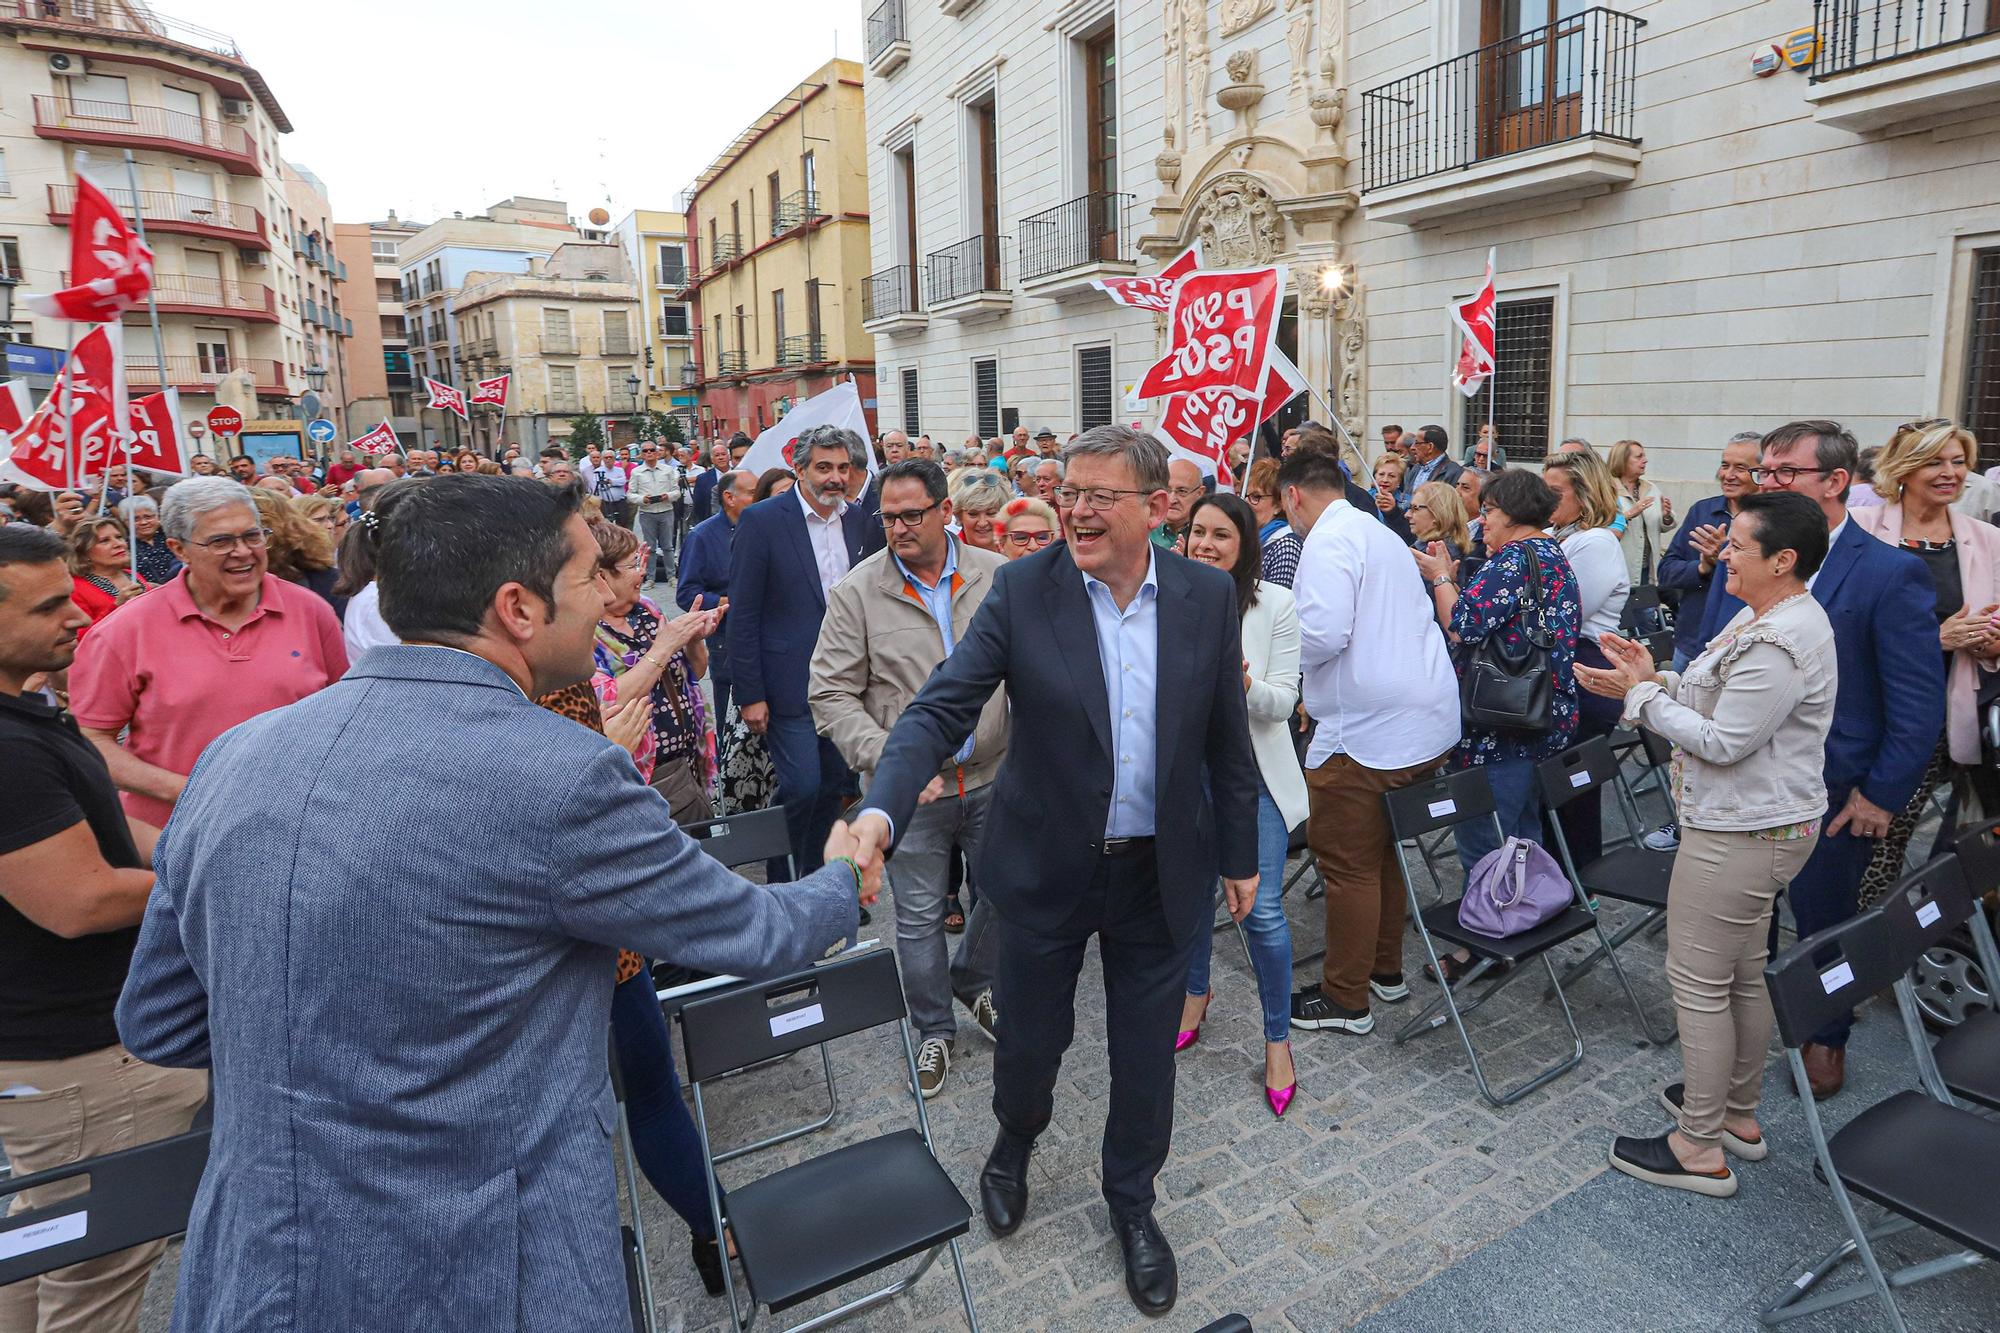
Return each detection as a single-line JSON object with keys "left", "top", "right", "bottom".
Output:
{"left": 612, "top": 973, "right": 716, "bottom": 1241}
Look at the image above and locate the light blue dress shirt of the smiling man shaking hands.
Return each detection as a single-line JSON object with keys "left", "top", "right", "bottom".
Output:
{"left": 1084, "top": 546, "right": 1160, "bottom": 839}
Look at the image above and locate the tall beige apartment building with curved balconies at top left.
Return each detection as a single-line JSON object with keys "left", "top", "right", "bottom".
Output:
{"left": 0, "top": 0, "right": 336, "bottom": 448}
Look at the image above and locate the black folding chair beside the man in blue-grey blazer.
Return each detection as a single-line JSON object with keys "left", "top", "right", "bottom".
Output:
{"left": 680, "top": 951, "right": 980, "bottom": 1333}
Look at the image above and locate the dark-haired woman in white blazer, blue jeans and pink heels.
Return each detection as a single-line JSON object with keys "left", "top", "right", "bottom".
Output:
{"left": 1174, "top": 492, "right": 1306, "bottom": 1117}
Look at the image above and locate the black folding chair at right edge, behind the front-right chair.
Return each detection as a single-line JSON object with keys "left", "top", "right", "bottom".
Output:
{"left": 1880, "top": 844, "right": 2000, "bottom": 1111}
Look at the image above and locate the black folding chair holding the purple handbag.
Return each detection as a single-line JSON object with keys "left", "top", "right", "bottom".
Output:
{"left": 1382, "top": 769, "right": 1598, "bottom": 1107}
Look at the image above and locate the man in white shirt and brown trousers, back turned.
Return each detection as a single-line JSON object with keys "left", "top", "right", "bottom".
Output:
{"left": 1278, "top": 448, "right": 1460, "bottom": 1035}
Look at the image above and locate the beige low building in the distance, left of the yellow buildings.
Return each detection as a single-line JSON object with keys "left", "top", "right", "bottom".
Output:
{"left": 452, "top": 240, "right": 646, "bottom": 454}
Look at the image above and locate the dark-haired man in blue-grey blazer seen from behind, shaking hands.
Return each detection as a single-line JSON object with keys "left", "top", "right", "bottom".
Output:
{"left": 118, "top": 476, "right": 858, "bottom": 1333}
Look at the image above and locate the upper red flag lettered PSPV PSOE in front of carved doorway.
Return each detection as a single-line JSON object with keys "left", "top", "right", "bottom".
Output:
{"left": 1138, "top": 264, "right": 1284, "bottom": 400}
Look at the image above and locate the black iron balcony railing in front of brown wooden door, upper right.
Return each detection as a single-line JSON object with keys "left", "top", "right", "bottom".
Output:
{"left": 1362, "top": 8, "right": 1646, "bottom": 192}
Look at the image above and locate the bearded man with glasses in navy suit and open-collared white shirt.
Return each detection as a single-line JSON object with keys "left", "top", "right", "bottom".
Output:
{"left": 724, "top": 426, "right": 872, "bottom": 879}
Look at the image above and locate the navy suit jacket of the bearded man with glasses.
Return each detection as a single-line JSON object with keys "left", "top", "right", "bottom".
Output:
{"left": 722, "top": 490, "right": 868, "bottom": 716}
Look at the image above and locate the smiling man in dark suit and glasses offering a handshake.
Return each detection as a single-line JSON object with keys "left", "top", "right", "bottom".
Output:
{"left": 854, "top": 426, "right": 1258, "bottom": 1315}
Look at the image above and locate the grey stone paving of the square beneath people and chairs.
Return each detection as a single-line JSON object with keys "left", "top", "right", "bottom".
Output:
{"left": 129, "top": 772, "right": 2000, "bottom": 1333}
